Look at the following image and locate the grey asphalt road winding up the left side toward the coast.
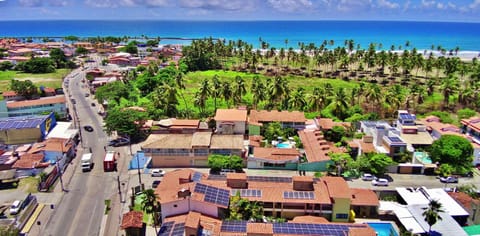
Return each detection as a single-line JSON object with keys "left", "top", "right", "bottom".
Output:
{"left": 43, "top": 61, "right": 121, "bottom": 236}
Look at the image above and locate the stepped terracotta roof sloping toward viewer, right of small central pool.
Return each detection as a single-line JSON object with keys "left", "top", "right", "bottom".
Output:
{"left": 298, "top": 130, "right": 343, "bottom": 162}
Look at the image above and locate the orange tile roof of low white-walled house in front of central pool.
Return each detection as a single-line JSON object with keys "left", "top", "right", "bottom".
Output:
{"left": 253, "top": 147, "right": 300, "bottom": 162}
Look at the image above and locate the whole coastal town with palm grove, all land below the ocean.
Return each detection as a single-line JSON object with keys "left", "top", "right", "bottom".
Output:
{"left": 0, "top": 33, "right": 480, "bottom": 236}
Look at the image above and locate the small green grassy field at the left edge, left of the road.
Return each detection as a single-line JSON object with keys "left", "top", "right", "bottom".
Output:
{"left": 0, "top": 69, "right": 71, "bottom": 96}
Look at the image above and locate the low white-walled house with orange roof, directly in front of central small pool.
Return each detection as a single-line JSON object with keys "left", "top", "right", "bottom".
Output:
{"left": 247, "top": 147, "right": 301, "bottom": 170}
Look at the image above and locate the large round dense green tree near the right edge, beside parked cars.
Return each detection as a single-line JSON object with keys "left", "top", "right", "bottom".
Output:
{"left": 430, "top": 135, "right": 473, "bottom": 172}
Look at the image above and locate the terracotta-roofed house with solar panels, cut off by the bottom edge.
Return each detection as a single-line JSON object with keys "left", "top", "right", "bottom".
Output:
{"left": 159, "top": 211, "right": 377, "bottom": 236}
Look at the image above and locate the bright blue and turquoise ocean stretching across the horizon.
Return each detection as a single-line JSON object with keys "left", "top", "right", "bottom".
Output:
{"left": 0, "top": 20, "right": 480, "bottom": 52}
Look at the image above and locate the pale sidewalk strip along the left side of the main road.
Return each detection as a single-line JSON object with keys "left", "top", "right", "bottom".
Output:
{"left": 27, "top": 145, "right": 83, "bottom": 236}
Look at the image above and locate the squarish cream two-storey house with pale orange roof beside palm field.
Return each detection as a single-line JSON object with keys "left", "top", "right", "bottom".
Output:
{"left": 213, "top": 109, "right": 247, "bottom": 134}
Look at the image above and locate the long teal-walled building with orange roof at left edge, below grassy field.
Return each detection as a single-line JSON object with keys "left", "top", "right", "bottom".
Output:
{"left": 0, "top": 95, "right": 67, "bottom": 117}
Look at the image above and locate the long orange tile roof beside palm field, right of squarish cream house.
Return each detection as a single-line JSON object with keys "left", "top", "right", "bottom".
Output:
{"left": 248, "top": 110, "right": 307, "bottom": 123}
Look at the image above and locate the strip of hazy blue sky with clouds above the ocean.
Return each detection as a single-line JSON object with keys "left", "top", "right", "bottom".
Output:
{"left": 0, "top": 0, "right": 480, "bottom": 22}
